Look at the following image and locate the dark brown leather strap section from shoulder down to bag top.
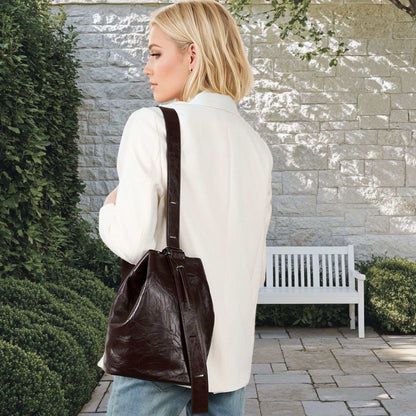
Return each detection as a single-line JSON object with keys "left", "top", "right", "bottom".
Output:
{"left": 159, "top": 106, "right": 181, "bottom": 248}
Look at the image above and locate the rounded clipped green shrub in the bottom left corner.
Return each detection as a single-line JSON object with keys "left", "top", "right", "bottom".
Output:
{"left": 0, "top": 340, "right": 68, "bottom": 416}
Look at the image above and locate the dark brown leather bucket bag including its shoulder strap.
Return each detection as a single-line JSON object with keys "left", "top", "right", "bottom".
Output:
{"left": 104, "top": 107, "right": 214, "bottom": 414}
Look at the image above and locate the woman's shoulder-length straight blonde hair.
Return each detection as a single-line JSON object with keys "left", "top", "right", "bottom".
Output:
{"left": 150, "top": 0, "right": 253, "bottom": 101}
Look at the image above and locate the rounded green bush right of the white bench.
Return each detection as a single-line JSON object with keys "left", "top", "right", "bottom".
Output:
{"left": 365, "top": 259, "right": 416, "bottom": 334}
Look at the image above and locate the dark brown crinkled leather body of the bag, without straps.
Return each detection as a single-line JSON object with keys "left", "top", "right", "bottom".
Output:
{"left": 104, "top": 247, "right": 214, "bottom": 385}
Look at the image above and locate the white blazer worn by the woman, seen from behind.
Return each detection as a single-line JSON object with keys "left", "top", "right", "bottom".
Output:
{"left": 99, "top": 92, "right": 273, "bottom": 393}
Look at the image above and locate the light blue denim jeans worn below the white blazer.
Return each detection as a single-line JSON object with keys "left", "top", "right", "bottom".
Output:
{"left": 107, "top": 376, "right": 245, "bottom": 416}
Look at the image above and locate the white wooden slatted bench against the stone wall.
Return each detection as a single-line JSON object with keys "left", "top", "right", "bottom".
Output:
{"left": 257, "top": 245, "right": 365, "bottom": 338}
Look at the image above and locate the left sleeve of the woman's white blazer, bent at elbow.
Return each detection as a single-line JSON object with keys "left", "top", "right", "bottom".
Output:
{"left": 99, "top": 108, "right": 164, "bottom": 264}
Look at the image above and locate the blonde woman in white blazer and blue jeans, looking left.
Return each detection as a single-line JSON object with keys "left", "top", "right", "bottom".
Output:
{"left": 99, "top": 0, "right": 273, "bottom": 416}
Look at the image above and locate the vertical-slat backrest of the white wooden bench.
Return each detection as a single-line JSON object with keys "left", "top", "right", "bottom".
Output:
{"left": 264, "top": 245, "right": 355, "bottom": 288}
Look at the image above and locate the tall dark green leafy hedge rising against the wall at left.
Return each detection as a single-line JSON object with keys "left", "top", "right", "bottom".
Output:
{"left": 0, "top": 0, "right": 83, "bottom": 276}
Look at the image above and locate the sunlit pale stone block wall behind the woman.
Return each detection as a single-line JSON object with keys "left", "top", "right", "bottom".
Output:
{"left": 55, "top": 0, "right": 416, "bottom": 260}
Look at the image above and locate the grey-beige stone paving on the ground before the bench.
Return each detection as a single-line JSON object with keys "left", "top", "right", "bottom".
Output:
{"left": 79, "top": 328, "right": 416, "bottom": 416}
